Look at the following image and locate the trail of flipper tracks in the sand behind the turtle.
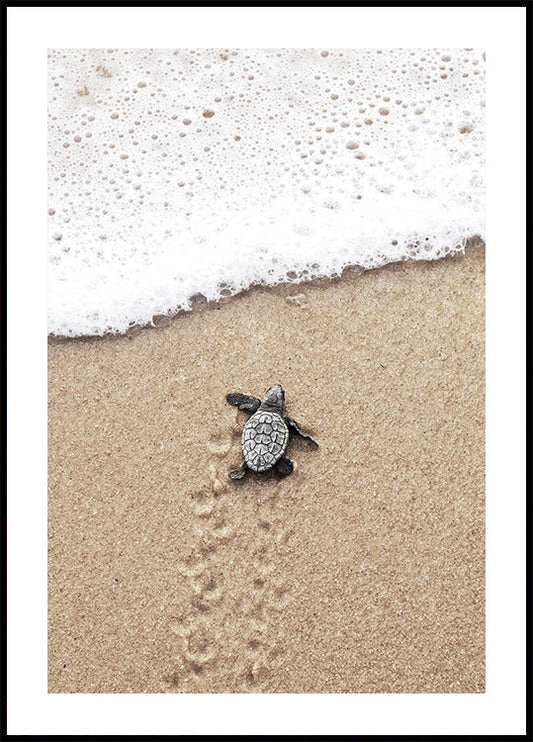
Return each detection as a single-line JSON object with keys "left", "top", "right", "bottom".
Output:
{"left": 166, "top": 428, "right": 292, "bottom": 693}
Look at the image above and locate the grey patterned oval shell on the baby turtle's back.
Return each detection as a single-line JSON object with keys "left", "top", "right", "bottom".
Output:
{"left": 241, "top": 410, "right": 289, "bottom": 472}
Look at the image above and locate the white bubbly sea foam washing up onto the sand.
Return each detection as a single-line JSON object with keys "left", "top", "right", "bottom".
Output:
{"left": 48, "top": 49, "right": 485, "bottom": 336}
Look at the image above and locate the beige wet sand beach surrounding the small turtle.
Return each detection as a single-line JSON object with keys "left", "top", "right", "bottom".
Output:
{"left": 49, "top": 244, "right": 485, "bottom": 693}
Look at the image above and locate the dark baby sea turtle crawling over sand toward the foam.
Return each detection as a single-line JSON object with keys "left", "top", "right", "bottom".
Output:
{"left": 226, "top": 384, "right": 318, "bottom": 479}
